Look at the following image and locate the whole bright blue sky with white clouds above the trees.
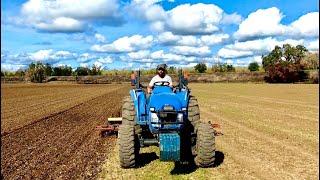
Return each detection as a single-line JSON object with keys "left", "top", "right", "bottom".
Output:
{"left": 1, "top": 0, "right": 319, "bottom": 71}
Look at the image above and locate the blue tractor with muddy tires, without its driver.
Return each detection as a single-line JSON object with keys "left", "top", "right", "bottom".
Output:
{"left": 118, "top": 70, "right": 215, "bottom": 168}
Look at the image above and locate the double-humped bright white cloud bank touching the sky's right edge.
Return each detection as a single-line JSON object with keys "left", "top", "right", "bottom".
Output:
{"left": 234, "top": 7, "right": 319, "bottom": 41}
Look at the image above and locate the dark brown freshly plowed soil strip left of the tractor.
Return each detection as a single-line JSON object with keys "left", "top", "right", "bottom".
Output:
{"left": 1, "top": 87, "right": 128, "bottom": 179}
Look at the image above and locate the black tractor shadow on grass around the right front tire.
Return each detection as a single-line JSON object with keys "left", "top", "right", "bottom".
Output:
{"left": 170, "top": 151, "right": 224, "bottom": 175}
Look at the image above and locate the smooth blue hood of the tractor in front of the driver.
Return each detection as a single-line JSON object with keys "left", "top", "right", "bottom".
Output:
{"left": 149, "top": 92, "right": 182, "bottom": 111}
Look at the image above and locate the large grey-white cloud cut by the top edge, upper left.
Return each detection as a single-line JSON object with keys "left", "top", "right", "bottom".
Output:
{"left": 17, "top": 0, "right": 122, "bottom": 32}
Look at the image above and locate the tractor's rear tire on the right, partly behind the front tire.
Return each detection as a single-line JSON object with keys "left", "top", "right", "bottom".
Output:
{"left": 188, "top": 96, "right": 200, "bottom": 128}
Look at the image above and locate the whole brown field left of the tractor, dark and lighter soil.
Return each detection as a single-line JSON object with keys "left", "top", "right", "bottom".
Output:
{"left": 1, "top": 84, "right": 129, "bottom": 179}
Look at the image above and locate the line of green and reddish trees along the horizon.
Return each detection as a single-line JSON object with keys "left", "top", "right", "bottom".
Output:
{"left": 1, "top": 44, "right": 319, "bottom": 83}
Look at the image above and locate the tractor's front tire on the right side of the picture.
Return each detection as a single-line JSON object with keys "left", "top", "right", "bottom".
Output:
{"left": 195, "top": 122, "right": 215, "bottom": 167}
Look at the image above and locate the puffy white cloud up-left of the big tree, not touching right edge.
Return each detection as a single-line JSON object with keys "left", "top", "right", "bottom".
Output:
{"left": 234, "top": 7, "right": 286, "bottom": 40}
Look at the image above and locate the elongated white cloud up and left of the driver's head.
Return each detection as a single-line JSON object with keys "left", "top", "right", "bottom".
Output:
{"left": 91, "top": 35, "right": 153, "bottom": 53}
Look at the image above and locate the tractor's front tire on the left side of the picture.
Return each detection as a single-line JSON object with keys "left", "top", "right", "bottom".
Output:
{"left": 118, "top": 124, "right": 140, "bottom": 168}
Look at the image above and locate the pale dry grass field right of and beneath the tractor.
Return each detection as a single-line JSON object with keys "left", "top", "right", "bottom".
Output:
{"left": 100, "top": 83, "right": 319, "bottom": 179}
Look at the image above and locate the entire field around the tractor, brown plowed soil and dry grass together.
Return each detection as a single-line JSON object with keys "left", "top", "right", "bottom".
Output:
{"left": 1, "top": 83, "right": 319, "bottom": 179}
